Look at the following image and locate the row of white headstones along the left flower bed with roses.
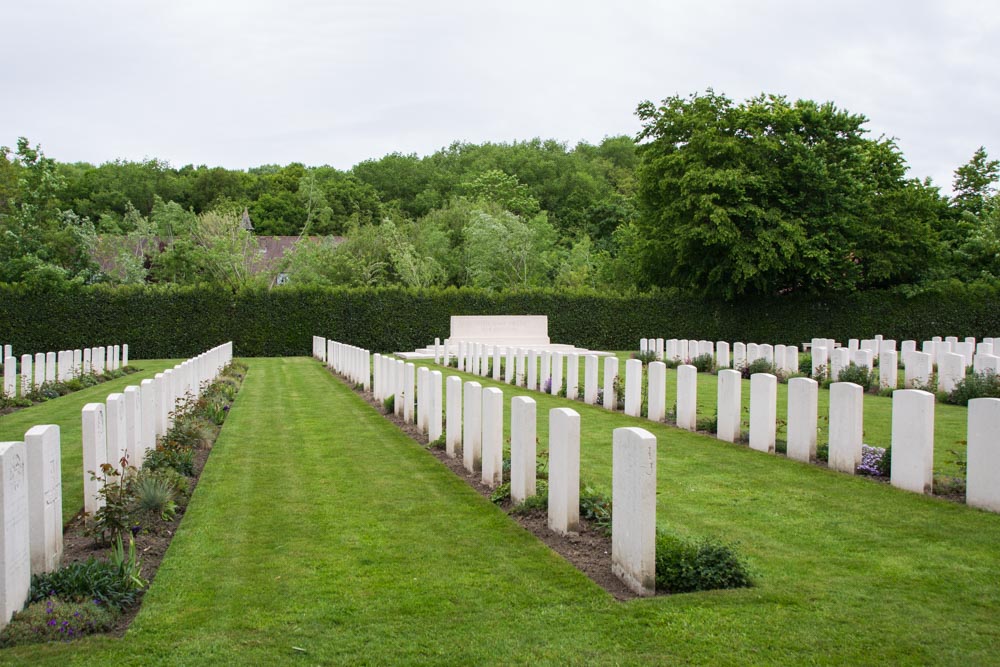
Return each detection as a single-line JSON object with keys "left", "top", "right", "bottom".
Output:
{"left": 0, "top": 343, "right": 232, "bottom": 627}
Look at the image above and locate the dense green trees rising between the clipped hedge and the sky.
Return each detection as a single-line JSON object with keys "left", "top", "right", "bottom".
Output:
{"left": 0, "top": 90, "right": 1000, "bottom": 299}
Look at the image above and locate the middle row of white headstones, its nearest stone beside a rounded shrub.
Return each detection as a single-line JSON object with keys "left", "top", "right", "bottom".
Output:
{"left": 313, "top": 337, "right": 656, "bottom": 596}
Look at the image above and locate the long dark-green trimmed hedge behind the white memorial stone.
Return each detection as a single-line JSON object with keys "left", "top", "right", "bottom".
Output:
{"left": 0, "top": 285, "right": 1000, "bottom": 359}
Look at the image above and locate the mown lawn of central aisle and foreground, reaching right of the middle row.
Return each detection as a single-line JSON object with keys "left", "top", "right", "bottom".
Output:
{"left": 0, "top": 358, "right": 1000, "bottom": 665}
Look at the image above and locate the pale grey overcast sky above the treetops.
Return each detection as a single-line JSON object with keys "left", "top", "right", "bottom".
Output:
{"left": 0, "top": 0, "right": 1000, "bottom": 190}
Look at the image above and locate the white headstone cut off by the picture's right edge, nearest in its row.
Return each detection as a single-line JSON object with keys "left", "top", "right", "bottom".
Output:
{"left": 968, "top": 398, "right": 1000, "bottom": 512}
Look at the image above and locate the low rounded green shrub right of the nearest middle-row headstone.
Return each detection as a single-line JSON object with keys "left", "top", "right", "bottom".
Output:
{"left": 656, "top": 531, "right": 753, "bottom": 593}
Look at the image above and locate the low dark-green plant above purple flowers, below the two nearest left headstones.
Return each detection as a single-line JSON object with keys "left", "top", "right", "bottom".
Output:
{"left": 28, "top": 557, "right": 141, "bottom": 609}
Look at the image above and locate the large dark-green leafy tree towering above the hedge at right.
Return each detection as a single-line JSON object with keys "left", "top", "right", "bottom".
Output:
{"left": 637, "top": 90, "right": 940, "bottom": 298}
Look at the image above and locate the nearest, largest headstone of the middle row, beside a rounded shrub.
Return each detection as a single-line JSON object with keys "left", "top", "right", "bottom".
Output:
{"left": 611, "top": 428, "right": 656, "bottom": 596}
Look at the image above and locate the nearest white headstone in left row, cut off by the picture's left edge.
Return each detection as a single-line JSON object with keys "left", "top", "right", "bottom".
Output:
{"left": 0, "top": 442, "right": 31, "bottom": 627}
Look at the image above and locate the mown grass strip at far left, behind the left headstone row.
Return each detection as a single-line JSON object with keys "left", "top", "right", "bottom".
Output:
{"left": 0, "top": 359, "right": 177, "bottom": 523}
